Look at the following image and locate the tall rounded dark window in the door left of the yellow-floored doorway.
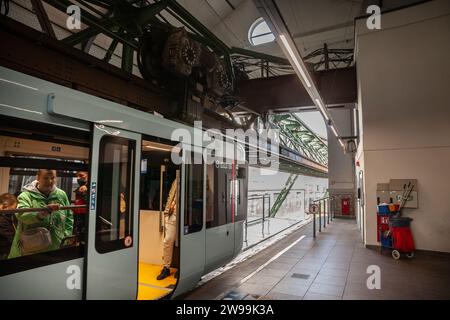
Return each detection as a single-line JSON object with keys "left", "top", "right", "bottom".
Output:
{"left": 95, "top": 136, "right": 136, "bottom": 253}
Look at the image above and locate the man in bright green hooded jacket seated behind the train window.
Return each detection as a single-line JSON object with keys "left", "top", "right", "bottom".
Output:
{"left": 8, "top": 169, "right": 73, "bottom": 259}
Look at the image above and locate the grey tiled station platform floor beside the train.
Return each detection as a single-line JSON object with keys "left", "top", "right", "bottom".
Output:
{"left": 182, "top": 219, "right": 450, "bottom": 300}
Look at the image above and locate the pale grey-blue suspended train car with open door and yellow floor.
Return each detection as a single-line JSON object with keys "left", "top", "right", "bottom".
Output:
{"left": 0, "top": 67, "right": 248, "bottom": 299}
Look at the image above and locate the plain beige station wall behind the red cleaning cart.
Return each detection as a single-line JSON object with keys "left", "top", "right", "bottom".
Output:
{"left": 355, "top": 0, "right": 450, "bottom": 252}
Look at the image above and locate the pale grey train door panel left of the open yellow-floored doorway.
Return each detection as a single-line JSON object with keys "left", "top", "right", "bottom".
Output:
{"left": 84, "top": 124, "right": 141, "bottom": 299}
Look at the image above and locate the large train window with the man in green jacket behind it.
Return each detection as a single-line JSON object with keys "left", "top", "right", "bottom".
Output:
{"left": 0, "top": 128, "right": 89, "bottom": 275}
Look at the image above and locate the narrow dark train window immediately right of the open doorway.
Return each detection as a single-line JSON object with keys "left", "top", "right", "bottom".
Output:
{"left": 184, "top": 156, "right": 203, "bottom": 234}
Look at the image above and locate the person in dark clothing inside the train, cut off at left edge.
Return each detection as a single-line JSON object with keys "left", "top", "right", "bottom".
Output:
{"left": 0, "top": 193, "right": 17, "bottom": 260}
